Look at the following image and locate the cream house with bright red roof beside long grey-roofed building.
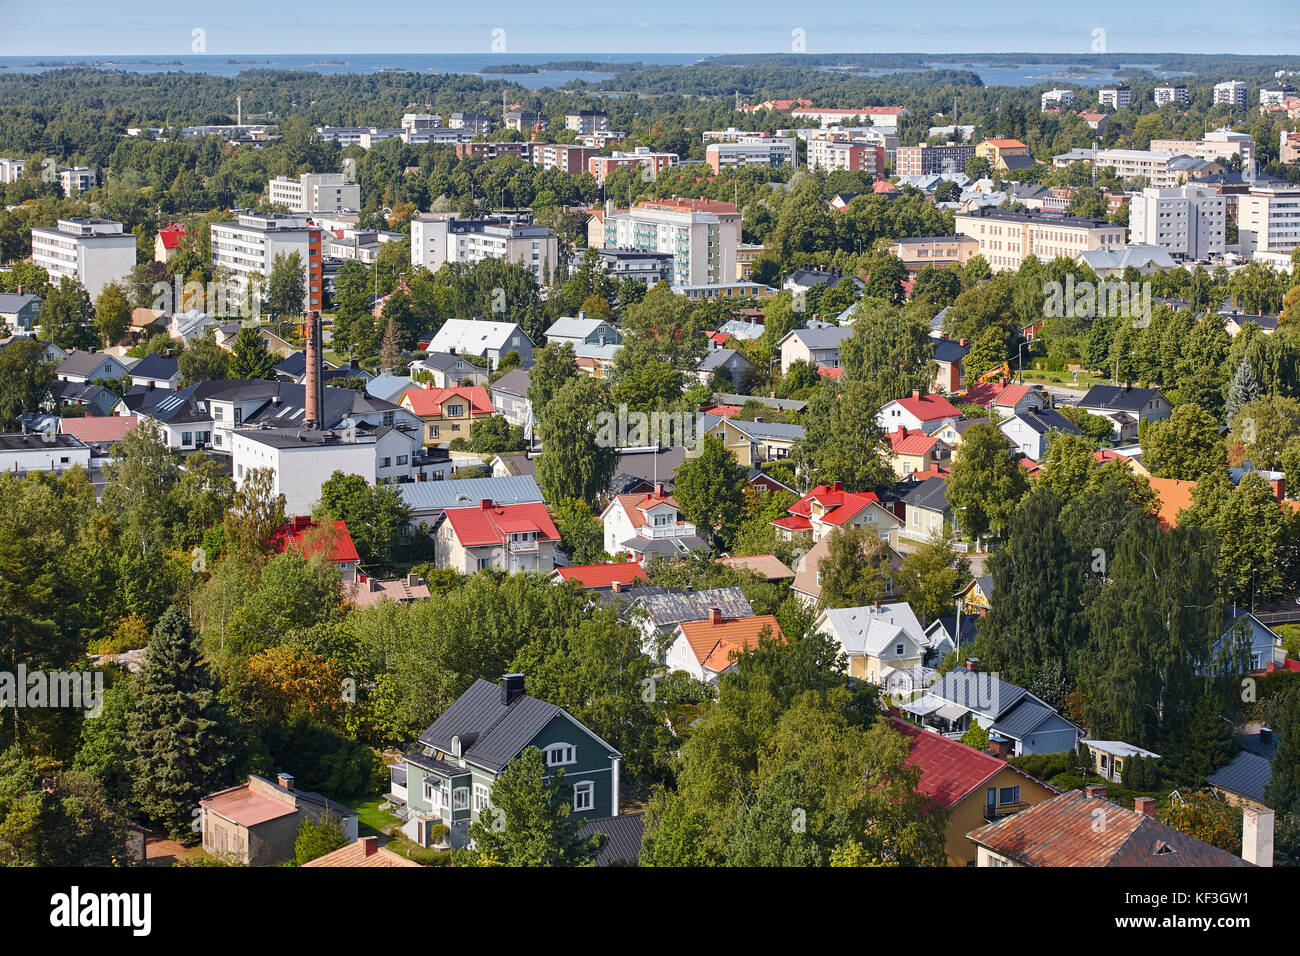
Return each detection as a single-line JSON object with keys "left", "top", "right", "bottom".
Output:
{"left": 433, "top": 498, "right": 560, "bottom": 574}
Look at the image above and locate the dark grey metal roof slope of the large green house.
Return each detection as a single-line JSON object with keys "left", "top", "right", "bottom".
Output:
{"left": 420, "top": 679, "right": 612, "bottom": 773}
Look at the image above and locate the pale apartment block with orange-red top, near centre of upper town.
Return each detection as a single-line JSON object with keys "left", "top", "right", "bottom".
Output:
{"left": 588, "top": 199, "right": 741, "bottom": 286}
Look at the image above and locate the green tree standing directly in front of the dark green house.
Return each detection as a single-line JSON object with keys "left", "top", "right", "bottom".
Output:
{"left": 469, "top": 747, "right": 605, "bottom": 866}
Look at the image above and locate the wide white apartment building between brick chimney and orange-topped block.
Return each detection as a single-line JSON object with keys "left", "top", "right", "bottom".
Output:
{"left": 411, "top": 212, "right": 558, "bottom": 282}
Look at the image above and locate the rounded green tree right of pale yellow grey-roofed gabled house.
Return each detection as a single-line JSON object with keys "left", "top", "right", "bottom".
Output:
{"left": 948, "top": 421, "right": 1028, "bottom": 537}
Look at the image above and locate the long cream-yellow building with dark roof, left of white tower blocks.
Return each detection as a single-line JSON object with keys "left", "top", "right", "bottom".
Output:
{"left": 954, "top": 207, "right": 1127, "bottom": 272}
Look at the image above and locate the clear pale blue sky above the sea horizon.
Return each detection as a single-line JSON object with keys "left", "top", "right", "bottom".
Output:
{"left": 0, "top": 0, "right": 1300, "bottom": 61}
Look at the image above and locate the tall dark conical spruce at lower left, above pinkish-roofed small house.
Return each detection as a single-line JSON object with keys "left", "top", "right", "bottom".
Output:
{"left": 127, "top": 605, "right": 234, "bottom": 839}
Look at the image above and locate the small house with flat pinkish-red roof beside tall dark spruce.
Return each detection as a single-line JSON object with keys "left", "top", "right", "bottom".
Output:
{"left": 199, "top": 774, "right": 356, "bottom": 866}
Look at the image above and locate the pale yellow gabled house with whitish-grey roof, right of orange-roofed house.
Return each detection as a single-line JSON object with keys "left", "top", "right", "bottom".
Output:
{"left": 813, "top": 602, "right": 935, "bottom": 689}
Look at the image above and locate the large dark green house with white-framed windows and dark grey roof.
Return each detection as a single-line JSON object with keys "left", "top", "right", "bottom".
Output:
{"left": 390, "top": 674, "right": 623, "bottom": 847}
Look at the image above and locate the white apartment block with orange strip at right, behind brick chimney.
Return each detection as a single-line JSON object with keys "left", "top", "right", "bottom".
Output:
{"left": 211, "top": 212, "right": 322, "bottom": 311}
